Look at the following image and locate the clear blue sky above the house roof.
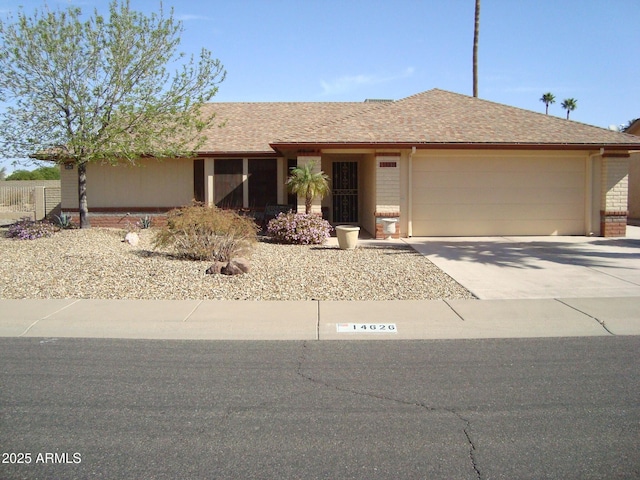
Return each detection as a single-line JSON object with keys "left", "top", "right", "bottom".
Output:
{"left": 0, "top": 0, "right": 640, "bottom": 171}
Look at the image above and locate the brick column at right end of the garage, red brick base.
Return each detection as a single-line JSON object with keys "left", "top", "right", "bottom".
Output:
{"left": 600, "top": 153, "right": 629, "bottom": 237}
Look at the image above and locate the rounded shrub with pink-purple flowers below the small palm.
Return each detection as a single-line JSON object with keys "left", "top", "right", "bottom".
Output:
{"left": 267, "top": 212, "right": 333, "bottom": 245}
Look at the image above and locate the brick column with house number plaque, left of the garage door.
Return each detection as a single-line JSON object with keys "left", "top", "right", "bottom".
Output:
{"left": 375, "top": 152, "right": 400, "bottom": 239}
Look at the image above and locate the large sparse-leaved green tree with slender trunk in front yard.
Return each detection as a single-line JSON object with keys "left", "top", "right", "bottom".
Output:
{"left": 0, "top": 0, "right": 225, "bottom": 228}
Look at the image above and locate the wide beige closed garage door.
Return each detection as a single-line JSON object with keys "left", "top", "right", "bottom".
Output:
{"left": 412, "top": 152, "right": 585, "bottom": 236}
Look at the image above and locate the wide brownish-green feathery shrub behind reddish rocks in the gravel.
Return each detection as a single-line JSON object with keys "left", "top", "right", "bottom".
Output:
{"left": 153, "top": 204, "right": 257, "bottom": 262}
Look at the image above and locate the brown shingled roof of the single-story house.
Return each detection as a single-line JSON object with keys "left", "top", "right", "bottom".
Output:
{"left": 196, "top": 89, "right": 640, "bottom": 154}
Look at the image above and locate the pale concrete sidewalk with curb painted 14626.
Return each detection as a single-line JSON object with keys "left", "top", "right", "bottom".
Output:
{"left": 0, "top": 297, "right": 640, "bottom": 340}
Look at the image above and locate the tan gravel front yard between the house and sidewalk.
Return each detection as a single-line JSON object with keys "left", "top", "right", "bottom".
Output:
{"left": 0, "top": 228, "right": 473, "bottom": 300}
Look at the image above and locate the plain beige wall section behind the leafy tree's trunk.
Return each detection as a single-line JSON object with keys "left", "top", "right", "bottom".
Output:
{"left": 61, "top": 159, "right": 193, "bottom": 211}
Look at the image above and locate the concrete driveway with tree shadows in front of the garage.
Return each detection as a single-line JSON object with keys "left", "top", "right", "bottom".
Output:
{"left": 405, "top": 226, "right": 640, "bottom": 299}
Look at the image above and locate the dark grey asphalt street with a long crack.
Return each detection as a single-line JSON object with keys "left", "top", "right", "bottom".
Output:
{"left": 0, "top": 336, "right": 640, "bottom": 480}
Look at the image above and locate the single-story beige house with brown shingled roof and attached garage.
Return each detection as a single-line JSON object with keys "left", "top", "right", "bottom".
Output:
{"left": 62, "top": 89, "right": 640, "bottom": 238}
